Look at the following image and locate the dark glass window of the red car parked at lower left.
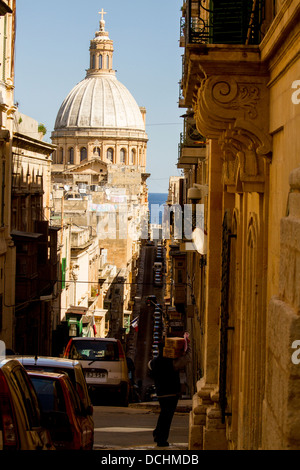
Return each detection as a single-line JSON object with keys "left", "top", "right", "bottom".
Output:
{"left": 30, "top": 376, "right": 66, "bottom": 412}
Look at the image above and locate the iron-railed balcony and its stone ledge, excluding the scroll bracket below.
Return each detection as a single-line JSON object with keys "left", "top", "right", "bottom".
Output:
{"left": 179, "top": 0, "right": 269, "bottom": 108}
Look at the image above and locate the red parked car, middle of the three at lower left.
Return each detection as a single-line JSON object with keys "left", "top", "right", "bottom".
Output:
{"left": 28, "top": 371, "right": 94, "bottom": 450}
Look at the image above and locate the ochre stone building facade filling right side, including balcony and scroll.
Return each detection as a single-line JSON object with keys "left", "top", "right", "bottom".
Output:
{"left": 180, "top": 0, "right": 300, "bottom": 449}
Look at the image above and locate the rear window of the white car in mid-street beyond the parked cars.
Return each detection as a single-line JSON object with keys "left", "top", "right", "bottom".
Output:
{"left": 71, "top": 340, "right": 119, "bottom": 361}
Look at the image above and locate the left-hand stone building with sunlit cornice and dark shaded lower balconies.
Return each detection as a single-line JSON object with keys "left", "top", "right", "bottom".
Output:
{"left": 11, "top": 111, "right": 60, "bottom": 355}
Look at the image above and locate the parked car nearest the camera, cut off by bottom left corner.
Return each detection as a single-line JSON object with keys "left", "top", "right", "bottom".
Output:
{"left": 0, "top": 359, "right": 54, "bottom": 450}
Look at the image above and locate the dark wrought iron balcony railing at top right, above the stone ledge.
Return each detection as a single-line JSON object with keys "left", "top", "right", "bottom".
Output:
{"left": 180, "top": 0, "right": 265, "bottom": 45}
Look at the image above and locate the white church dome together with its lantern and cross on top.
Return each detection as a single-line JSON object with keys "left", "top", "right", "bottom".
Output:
{"left": 54, "top": 9, "right": 145, "bottom": 133}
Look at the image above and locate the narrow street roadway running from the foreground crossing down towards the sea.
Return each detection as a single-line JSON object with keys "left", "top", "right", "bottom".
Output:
{"left": 88, "top": 242, "right": 191, "bottom": 451}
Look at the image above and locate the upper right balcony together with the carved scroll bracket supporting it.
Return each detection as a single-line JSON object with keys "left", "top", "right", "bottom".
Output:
{"left": 181, "top": 0, "right": 276, "bottom": 192}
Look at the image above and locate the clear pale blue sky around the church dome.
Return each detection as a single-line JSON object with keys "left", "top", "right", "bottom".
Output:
{"left": 15, "top": 0, "right": 185, "bottom": 193}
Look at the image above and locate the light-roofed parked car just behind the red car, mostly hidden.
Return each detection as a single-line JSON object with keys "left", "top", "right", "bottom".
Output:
{"left": 15, "top": 356, "right": 94, "bottom": 426}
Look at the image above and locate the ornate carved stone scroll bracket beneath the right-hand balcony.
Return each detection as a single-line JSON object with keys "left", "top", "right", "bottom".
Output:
{"left": 193, "top": 75, "right": 271, "bottom": 192}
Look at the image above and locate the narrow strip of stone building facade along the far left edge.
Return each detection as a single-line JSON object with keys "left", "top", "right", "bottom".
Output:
{"left": 0, "top": 0, "right": 16, "bottom": 348}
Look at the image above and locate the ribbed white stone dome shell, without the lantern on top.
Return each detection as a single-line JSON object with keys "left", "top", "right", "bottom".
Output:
{"left": 55, "top": 73, "right": 145, "bottom": 131}
